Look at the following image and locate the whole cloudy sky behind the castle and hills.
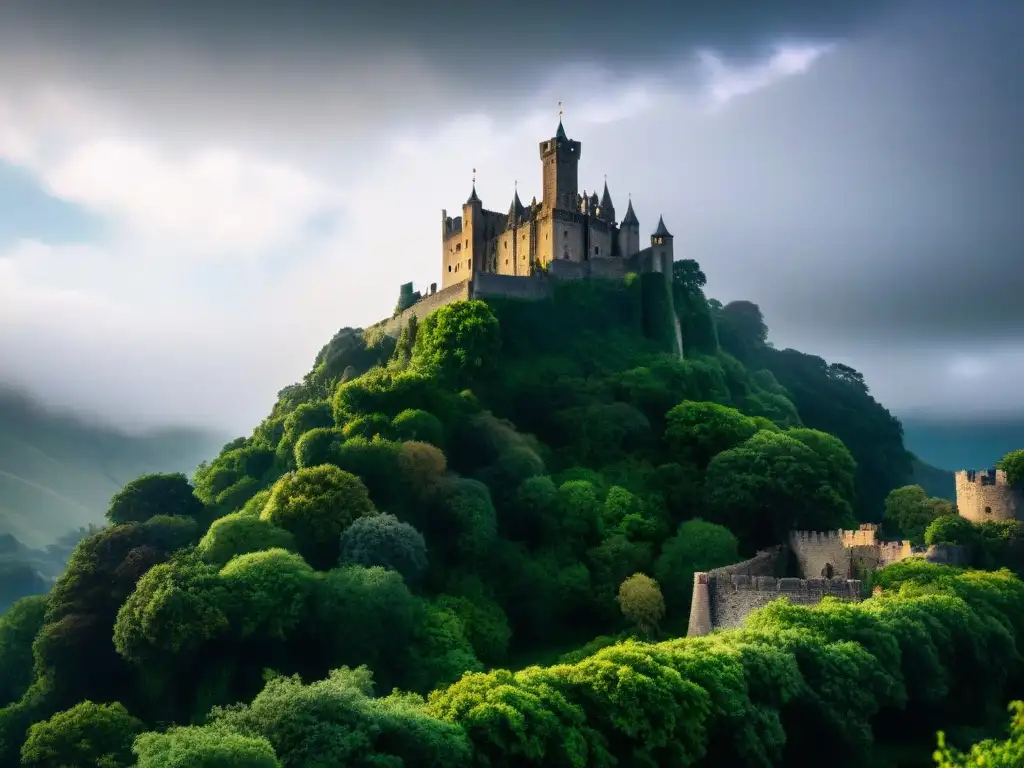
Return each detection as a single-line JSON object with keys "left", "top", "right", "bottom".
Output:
{"left": 0, "top": 0, "right": 1024, "bottom": 432}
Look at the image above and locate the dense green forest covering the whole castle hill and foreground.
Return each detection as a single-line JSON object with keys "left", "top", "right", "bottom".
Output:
{"left": 0, "top": 261, "right": 1024, "bottom": 768}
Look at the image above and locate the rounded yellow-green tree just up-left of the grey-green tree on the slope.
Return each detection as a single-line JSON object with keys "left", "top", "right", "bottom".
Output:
{"left": 260, "top": 464, "right": 378, "bottom": 568}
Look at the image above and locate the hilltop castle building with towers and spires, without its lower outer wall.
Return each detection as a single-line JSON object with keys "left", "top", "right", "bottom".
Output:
{"left": 441, "top": 119, "right": 673, "bottom": 289}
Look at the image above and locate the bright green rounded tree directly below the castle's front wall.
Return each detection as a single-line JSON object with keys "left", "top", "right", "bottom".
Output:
{"left": 413, "top": 300, "right": 501, "bottom": 388}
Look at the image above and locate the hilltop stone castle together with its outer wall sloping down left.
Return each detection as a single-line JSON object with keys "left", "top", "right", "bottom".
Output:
{"left": 375, "top": 115, "right": 682, "bottom": 339}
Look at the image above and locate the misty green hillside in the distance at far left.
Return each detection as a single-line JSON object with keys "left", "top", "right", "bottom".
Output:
{"left": 0, "top": 385, "right": 228, "bottom": 547}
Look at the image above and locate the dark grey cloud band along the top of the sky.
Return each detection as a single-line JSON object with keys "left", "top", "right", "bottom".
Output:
{"left": 0, "top": 0, "right": 921, "bottom": 150}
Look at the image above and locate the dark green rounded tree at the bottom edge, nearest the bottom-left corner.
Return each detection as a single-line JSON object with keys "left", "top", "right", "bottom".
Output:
{"left": 22, "top": 701, "right": 143, "bottom": 768}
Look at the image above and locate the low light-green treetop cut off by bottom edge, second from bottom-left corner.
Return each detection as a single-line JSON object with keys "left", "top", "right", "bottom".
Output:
{"left": 133, "top": 726, "right": 282, "bottom": 768}
